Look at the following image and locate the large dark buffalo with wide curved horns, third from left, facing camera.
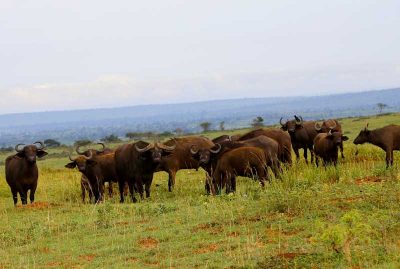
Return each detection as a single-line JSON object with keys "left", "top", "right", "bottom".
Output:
{"left": 115, "top": 141, "right": 176, "bottom": 203}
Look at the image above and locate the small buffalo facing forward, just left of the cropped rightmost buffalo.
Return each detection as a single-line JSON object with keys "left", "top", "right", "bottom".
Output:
{"left": 314, "top": 130, "right": 349, "bottom": 166}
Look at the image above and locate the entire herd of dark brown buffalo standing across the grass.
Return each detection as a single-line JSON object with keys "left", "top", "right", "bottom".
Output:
{"left": 5, "top": 115, "right": 400, "bottom": 205}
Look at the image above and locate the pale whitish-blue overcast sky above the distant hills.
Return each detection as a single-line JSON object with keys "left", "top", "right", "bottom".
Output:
{"left": 0, "top": 0, "right": 400, "bottom": 114}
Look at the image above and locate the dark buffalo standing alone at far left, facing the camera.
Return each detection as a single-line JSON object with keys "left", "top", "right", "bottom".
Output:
{"left": 6, "top": 142, "right": 47, "bottom": 205}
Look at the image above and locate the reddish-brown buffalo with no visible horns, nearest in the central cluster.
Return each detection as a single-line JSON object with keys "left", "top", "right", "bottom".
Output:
{"left": 213, "top": 147, "right": 268, "bottom": 193}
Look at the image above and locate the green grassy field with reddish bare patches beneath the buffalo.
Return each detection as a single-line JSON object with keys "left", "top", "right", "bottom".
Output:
{"left": 0, "top": 114, "right": 400, "bottom": 268}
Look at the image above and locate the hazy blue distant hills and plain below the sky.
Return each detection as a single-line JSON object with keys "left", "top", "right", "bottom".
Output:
{"left": 0, "top": 88, "right": 400, "bottom": 146}
